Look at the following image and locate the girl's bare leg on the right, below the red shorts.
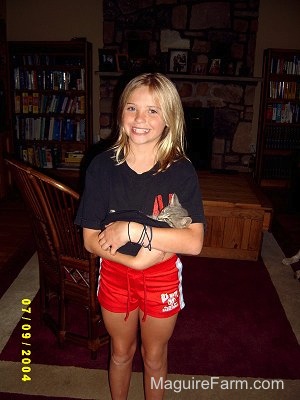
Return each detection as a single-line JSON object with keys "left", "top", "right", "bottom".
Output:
{"left": 140, "top": 313, "right": 177, "bottom": 400}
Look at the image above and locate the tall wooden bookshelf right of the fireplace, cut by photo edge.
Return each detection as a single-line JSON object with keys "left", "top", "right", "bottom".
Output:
{"left": 255, "top": 49, "right": 300, "bottom": 189}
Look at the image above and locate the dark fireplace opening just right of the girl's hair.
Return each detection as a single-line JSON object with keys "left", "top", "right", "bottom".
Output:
{"left": 184, "top": 107, "right": 214, "bottom": 170}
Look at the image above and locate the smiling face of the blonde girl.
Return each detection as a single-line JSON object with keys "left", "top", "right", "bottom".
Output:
{"left": 122, "top": 86, "right": 166, "bottom": 145}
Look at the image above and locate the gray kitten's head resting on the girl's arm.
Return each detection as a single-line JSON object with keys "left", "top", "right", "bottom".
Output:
{"left": 156, "top": 193, "right": 192, "bottom": 228}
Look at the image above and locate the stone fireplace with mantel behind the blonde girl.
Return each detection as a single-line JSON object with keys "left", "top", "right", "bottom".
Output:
{"left": 100, "top": 0, "right": 259, "bottom": 171}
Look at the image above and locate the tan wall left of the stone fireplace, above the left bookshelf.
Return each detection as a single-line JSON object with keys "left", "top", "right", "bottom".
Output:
{"left": 7, "top": 0, "right": 102, "bottom": 138}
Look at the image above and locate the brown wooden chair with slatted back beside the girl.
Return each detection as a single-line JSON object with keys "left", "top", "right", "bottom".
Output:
{"left": 6, "top": 159, "right": 108, "bottom": 358}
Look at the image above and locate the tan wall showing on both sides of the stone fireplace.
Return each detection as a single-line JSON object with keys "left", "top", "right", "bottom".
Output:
{"left": 7, "top": 0, "right": 300, "bottom": 147}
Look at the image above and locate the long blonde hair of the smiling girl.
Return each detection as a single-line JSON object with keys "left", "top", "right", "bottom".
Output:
{"left": 113, "top": 73, "right": 186, "bottom": 172}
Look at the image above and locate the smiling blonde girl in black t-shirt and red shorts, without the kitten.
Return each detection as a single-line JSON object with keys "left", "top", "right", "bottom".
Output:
{"left": 75, "top": 73, "right": 204, "bottom": 400}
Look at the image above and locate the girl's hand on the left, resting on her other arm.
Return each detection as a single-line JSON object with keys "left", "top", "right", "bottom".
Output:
{"left": 98, "top": 221, "right": 128, "bottom": 255}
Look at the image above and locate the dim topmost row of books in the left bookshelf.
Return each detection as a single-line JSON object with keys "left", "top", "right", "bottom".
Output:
{"left": 12, "top": 53, "right": 84, "bottom": 66}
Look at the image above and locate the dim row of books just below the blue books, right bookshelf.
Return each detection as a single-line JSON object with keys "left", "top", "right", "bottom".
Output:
{"left": 265, "top": 126, "right": 300, "bottom": 150}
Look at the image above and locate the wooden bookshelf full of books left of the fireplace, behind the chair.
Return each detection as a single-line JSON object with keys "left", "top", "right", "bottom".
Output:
{"left": 8, "top": 40, "right": 92, "bottom": 171}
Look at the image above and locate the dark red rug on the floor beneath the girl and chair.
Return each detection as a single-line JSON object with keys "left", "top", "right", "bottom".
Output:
{"left": 1, "top": 257, "right": 300, "bottom": 379}
